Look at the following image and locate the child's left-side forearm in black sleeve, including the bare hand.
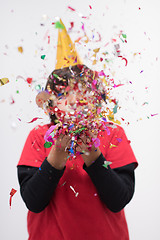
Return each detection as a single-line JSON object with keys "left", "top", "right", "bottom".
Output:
{"left": 18, "top": 134, "right": 70, "bottom": 213}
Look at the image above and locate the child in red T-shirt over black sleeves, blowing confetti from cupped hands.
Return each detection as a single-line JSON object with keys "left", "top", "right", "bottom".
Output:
{"left": 18, "top": 19, "right": 137, "bottom": 240}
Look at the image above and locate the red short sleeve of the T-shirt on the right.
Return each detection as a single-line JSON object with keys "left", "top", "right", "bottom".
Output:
{"left": 100, "top": 125, "right": 138, "bottom": 168}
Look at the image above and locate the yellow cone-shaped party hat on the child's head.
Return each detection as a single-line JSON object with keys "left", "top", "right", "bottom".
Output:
{"left": 55, "top": 19, "right": 83, "bottom": 69}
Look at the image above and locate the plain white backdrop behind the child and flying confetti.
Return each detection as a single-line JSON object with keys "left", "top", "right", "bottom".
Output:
{"left": 0, "top": 0, "right": 160, "bottom": 240}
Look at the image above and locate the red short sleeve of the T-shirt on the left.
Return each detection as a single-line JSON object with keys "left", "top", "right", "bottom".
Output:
{"left": 18, "top": 126, "right": 47, "bottom": 167}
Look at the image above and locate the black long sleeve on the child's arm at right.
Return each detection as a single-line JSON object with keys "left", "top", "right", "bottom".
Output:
{"left": 84, "top": 154, "right": 135, "bottom": 212}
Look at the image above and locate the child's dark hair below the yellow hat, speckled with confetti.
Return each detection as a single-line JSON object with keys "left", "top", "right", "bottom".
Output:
{"left": 45, "top": 64, "right": 98, "bottom": 123}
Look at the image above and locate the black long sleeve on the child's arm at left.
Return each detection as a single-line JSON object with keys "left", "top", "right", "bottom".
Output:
{"left": 18, "top": 159, "right": 65, "bottom": 213}
